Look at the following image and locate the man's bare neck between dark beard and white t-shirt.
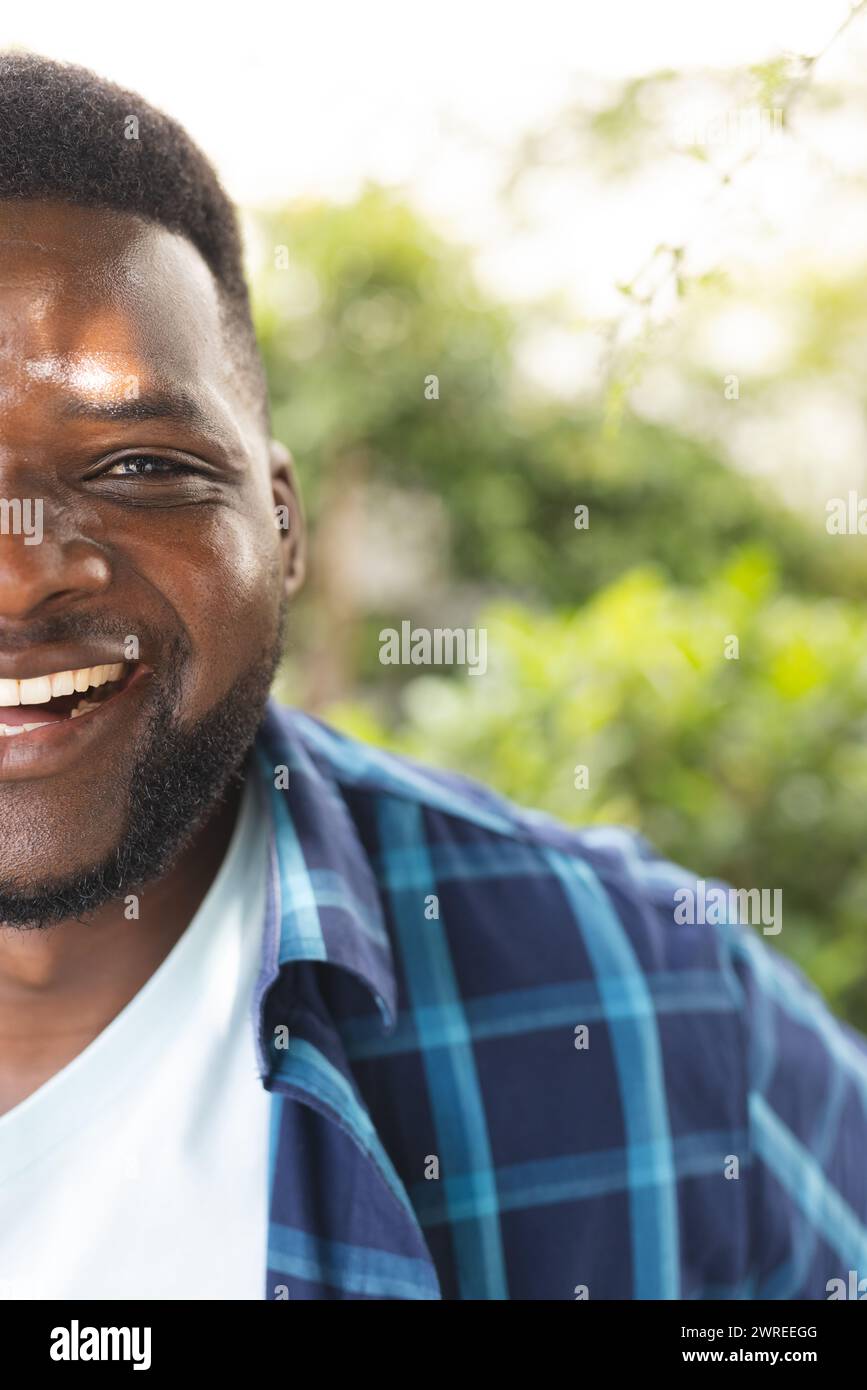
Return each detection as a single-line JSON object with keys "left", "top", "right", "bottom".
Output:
{"left": 0, "top": 788, "right": 240, "bottom": 1113}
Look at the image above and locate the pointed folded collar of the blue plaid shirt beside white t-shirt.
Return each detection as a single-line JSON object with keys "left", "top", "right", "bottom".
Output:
{"left": 254, "top": 702, "right": 397, "bottom": 1074}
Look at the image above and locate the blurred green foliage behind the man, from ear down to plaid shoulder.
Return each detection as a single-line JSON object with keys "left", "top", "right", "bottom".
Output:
{"left": 254, "top": 188, "right": 867, "bottom": 1027}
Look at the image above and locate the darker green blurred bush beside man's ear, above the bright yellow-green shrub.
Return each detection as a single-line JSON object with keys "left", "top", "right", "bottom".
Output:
{"left": 256, "top": 188, "right": 867, "bottom": 616}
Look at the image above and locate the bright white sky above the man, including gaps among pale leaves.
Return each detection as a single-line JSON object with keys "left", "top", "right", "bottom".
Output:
{"left": 0, "top": 0, "right": 867, "bottom": 503}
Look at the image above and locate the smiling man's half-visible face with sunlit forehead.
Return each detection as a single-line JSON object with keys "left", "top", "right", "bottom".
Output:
{"left": 0, "top": 202, "right": 301, "bottom": 911}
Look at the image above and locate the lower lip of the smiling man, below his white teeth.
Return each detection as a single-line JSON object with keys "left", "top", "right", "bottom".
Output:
{"left": 0, "top": 663, "right": 151, "bottom": 781}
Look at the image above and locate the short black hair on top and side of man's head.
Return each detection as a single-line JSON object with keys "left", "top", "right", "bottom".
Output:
{"left": 0, "top": 51, "right": 270, "bottom": 428}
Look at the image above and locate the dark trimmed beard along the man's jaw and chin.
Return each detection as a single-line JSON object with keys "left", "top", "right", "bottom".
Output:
{"left": 0, "top": 605, "right": 285, "bottom": 929}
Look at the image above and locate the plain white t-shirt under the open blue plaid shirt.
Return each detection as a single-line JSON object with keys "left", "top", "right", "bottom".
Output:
{"left": 0, "top": 778, "right": 271, "bottom": 1298}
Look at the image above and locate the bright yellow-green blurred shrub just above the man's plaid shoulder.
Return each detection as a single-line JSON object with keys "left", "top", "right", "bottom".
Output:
{"left": 332, "top": 553, "right": 867, "bottom": 1027}
